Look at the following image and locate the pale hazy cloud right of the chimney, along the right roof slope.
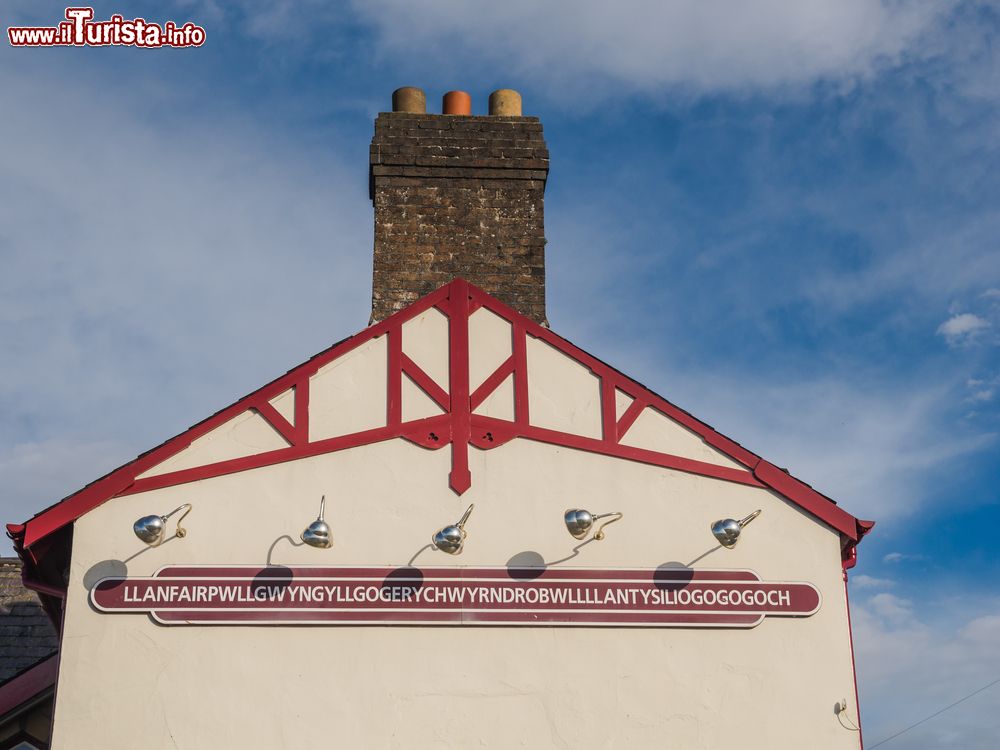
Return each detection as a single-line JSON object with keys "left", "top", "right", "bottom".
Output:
{"left": 548, "top": 207, "right": 997, "bottom": 531}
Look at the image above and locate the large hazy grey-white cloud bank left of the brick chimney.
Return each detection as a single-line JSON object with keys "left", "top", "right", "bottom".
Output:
{"left": 0, "top": 50, "right": 372, "bottom": 552}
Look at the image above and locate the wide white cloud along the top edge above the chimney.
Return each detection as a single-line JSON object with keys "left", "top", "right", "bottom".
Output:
{"left": 354, "top": 0, "right": 951, "bottom": 94}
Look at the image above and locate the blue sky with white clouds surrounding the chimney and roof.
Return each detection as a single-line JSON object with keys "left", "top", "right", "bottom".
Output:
{"left": 0, "top": 0, "right": 1000, "bottom": 748}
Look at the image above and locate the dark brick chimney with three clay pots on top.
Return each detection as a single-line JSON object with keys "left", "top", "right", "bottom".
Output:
{"left": 370, "top": 88, "right": 549, "bottom": 324}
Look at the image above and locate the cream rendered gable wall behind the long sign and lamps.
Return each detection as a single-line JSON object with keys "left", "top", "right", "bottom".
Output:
{"left": 52, "top": 313, "right": 858, "bottom": 750}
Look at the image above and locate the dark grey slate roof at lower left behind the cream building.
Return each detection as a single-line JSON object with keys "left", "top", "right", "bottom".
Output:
{"left": 0, "top": 557, "right": 59, "bottom": 683}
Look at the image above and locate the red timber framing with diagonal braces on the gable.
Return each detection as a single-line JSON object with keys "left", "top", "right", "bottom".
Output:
{"left": 8, "top": 279, "right": 872, "bottom": 576}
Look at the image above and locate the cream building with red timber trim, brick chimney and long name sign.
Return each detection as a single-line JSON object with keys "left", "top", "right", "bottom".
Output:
{"left": 8, "top": 89, "right": 872, "bottom": 750}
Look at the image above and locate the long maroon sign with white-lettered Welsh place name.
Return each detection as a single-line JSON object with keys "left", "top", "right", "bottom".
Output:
{"left": 90, "top": 566, "right": 820, "bottom": 628}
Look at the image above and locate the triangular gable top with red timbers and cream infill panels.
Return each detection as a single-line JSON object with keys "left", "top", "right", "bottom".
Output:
{"left": 8, "top": 279, "right": 873, "bottom": 576}
